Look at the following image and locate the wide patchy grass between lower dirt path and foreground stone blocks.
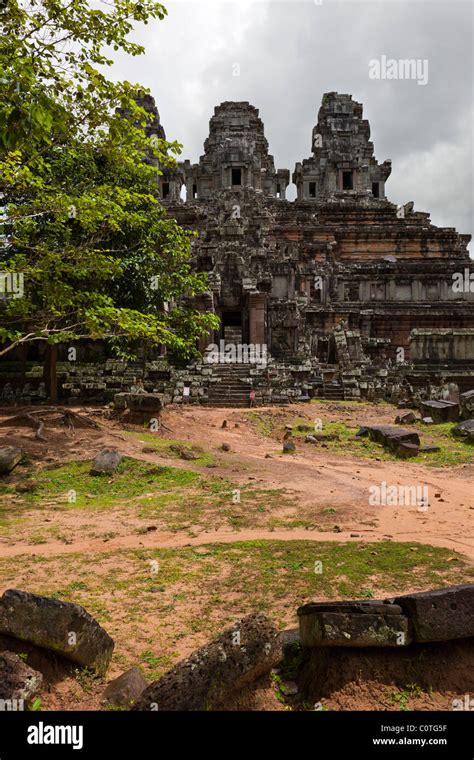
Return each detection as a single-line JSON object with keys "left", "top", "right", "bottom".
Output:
{"left": 0, "top": 541, "right": 472, "bottom": 678}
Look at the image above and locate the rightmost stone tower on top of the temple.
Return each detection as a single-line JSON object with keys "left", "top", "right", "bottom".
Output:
{"left": 293, "top": 92, "right": 392, "bottom": 201}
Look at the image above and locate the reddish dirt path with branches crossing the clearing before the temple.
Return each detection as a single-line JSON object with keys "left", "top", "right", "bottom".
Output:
{"left": 0, "top": 403, "right": 474, "bottom": 559}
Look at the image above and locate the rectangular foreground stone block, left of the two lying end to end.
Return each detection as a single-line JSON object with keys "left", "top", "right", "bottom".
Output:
{"left": 298, "top": 602, "right": 411, "bottom": 647}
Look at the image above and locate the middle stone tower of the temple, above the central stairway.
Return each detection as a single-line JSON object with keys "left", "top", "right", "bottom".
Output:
{"left": 181, "top": 102, "right": 290, "bottom": 200}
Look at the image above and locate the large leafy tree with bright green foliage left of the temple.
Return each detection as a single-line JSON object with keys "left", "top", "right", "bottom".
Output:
{"left": 0, "top": 0, "right": 216, "bottom": 392}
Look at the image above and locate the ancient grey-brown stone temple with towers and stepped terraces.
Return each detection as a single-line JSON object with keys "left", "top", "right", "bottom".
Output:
{"left": 0, "top": 92, "right": 474, "bottom": 404}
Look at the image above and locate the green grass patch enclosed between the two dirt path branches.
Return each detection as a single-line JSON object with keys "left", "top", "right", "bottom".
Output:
{"left": 0, "top": 458, "right": 300, "bottom": 544}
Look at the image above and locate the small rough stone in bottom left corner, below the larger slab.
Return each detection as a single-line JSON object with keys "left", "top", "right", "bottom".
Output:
{"left": 0, "top": 652, "right": 43, "bottom": 712}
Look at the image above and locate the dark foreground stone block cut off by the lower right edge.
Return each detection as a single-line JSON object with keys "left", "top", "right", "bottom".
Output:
{"left": 392, "top": 584, "right": 474, "bottom": 642}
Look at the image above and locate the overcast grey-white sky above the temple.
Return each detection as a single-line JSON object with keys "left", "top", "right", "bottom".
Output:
{"left": 108, "top": 0, "right": 474, "bottom": 255}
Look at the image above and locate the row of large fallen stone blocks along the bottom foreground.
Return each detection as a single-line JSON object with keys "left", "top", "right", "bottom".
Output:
{"left": 0, "top": 584, "right": 474, "bottom": 712}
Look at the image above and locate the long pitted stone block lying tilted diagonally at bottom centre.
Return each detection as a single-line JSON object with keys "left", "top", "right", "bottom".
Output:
{"left": 132, "top": 613, "right": 282, "bottom": 711}
